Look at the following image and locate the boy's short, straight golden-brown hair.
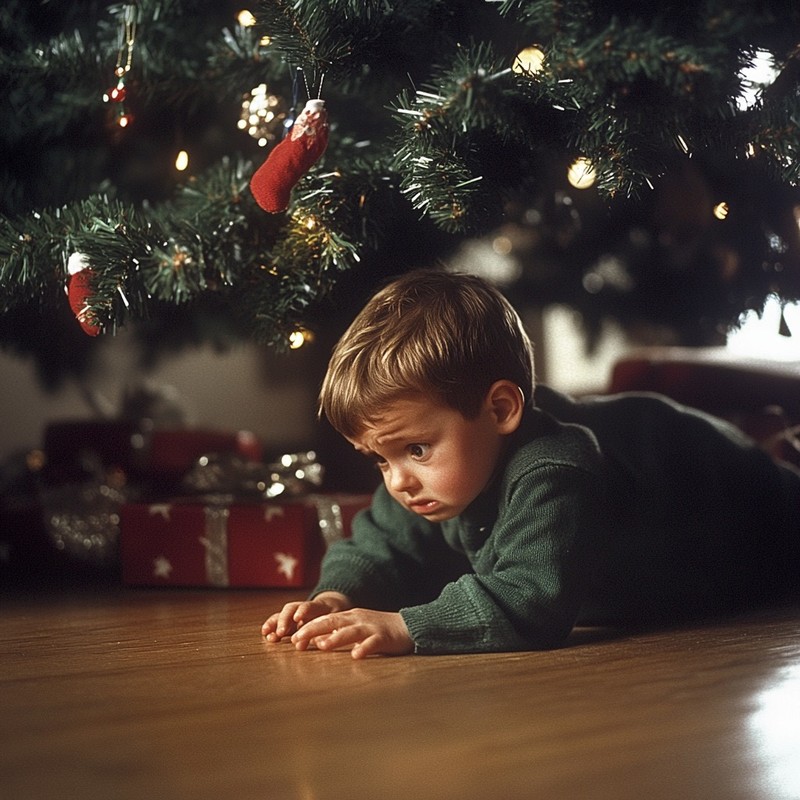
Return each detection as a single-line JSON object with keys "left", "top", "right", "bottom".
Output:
{"left": 319, "top": 270, "right": 534, "bottom": 437}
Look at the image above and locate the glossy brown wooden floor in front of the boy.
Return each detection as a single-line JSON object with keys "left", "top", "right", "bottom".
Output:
{"left": 0, "top": 590, "right": 800, "bottom": 800}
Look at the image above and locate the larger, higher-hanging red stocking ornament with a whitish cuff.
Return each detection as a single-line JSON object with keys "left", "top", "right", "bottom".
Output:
{"left": 250, "top": 100, "right": 328, "bottom": 214}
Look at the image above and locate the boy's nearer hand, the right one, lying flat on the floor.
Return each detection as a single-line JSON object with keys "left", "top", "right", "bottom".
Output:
{"left": 292, "top": 608, "right": 414, "bottom": 658}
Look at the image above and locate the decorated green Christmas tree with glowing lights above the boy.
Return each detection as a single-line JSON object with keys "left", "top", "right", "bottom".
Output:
{"left": 0, "top": 0, "right": 800, "bottom": 382}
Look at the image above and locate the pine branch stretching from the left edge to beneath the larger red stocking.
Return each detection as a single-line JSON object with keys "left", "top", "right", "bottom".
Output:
{"left": 0, "top": 145, "right": 396, "bottom": 344}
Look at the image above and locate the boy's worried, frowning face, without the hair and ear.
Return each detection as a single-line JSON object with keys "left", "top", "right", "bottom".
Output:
{"left": 349, "top": 395, "right": 505, "bottom": 522}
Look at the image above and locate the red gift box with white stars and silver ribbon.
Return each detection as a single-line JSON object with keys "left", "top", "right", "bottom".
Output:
{"left": 120, "top": 495, "right": 371, "bottom": 587}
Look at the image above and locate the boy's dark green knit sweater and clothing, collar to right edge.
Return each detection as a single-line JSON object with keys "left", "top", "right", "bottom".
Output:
{"left": 312, "top": 387, "right": 800, "bottom": 653}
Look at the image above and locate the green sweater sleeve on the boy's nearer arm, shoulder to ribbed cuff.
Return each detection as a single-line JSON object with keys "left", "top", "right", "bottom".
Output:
{"left": 400, "top": 450, "right": 604, "bottom": 654}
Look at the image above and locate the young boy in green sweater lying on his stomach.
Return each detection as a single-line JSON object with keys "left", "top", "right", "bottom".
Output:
{"left": 262, "top": 271, "right": 800, "bottom": 658}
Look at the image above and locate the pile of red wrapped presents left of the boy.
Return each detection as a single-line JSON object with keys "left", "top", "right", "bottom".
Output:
{"left": 0, "top": 400, "right": 370, "bottom": 587}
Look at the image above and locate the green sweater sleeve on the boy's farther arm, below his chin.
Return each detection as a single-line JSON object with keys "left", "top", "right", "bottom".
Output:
{"left": 311, "top": 486, "right": 470, "bottom": 611}
